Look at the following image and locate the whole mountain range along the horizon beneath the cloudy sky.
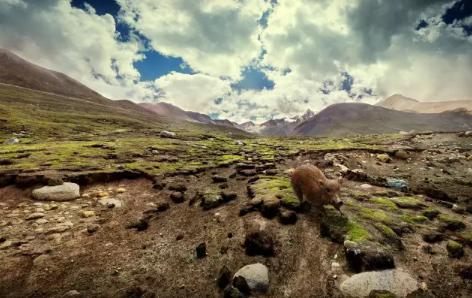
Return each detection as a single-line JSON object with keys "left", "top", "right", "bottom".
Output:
{"left": 0, "top": 49, "right": 472, "bottom": 136}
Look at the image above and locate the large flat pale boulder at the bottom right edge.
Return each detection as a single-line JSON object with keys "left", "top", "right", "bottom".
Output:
{"left": 341, "top": 269, "right": 418, "bottom": 297}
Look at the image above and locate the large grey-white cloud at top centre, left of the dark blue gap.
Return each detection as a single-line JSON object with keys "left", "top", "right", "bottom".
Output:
{"left": 118, "top": 0, "right": 269, "bottom": 79}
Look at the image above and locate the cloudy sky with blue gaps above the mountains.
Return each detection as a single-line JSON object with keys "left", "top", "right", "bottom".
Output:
{"left": 0, "top": 0, "right": 472, "bottom": 123}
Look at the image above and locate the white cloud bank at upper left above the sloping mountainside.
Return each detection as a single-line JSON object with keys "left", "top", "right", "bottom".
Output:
{"left": 0, "top": 0, "right": 152, "bottom": 99}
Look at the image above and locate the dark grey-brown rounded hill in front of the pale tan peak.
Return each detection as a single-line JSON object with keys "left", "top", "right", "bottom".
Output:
{"left": 293, "top": 103, "right": 472, "bottom": 136}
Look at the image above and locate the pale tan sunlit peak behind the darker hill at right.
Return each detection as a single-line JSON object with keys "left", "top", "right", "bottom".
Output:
{"left": 376, "top": 94, "right": 472, "bottom": 113}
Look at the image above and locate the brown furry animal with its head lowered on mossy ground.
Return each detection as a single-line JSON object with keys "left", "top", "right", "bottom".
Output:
{"left": 292, "top": 165, "right": 343, "bottom": 211}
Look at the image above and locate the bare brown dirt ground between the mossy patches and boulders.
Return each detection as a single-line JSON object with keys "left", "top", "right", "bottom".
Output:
{"left": 0, "top": 135, "right": 472, "bottom": 297}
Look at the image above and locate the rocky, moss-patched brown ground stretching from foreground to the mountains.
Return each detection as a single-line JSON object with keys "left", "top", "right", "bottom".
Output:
{"left": 0, "top": 133, "right": 472, "bottom": 297}
